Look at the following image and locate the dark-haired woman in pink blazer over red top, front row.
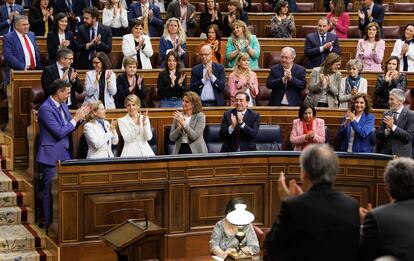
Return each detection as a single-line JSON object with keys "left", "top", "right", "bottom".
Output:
{"left": 290, "top": 103, "right": 325, "bottom": 151}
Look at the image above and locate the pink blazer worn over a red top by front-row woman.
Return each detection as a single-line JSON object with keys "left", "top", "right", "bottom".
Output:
{"left": 290, "top": 118, "right": 325, "bottom": 151}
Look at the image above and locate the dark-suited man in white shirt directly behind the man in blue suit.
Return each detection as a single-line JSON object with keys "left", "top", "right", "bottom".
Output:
{"left": 41, "top": 48, "right": 83, "bottom": 110}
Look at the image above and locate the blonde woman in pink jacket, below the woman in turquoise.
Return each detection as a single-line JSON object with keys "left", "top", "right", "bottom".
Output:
{"left": 228, "top": 53, "right": 259, "bottom": 106}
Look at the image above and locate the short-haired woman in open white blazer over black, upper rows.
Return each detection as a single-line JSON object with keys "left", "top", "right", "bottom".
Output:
{"left": 122, "top": 20, "right": 153, "bottom": 69}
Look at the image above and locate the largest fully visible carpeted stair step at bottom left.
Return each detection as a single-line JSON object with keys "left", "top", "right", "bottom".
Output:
{"left": 0, "top": 224, "right": 46, "bottom": 252}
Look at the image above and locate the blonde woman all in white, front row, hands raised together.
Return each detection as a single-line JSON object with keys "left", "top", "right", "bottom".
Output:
{"left": 118, "top": 94, "right": 155, "bottom": 157}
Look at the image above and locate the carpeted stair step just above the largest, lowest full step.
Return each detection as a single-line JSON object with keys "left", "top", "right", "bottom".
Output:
{"left": 0, "top": 207, "right": 34, "bottom": 226}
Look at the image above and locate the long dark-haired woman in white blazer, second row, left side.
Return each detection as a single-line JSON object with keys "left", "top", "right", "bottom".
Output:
{"left": 84, "top": 52, "right": 116, "bottom": 109}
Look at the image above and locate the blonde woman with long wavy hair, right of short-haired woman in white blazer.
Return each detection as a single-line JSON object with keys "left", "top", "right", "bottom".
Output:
{"left": 160, "top": 17, "right": 187, "bottom": 68}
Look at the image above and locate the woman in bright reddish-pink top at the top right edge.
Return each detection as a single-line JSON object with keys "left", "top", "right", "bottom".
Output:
{"left": 326, "top": 0, "right": 349, "bottom": 39}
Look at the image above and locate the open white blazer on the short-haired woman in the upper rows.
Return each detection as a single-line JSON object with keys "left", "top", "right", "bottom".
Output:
{"left": 122, "top": 34, "right": 154, "bottom": 69}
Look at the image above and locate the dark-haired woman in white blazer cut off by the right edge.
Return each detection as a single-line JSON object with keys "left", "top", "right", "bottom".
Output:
{"left": 391, "top": 24, "right": 414, "bottom": 72}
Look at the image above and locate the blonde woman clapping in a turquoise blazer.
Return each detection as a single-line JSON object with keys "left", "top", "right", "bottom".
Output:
{"left": 226, "top": 20, "right": 260, "bottom": 69}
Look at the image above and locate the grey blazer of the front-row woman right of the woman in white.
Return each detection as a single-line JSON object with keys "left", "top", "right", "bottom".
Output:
{"left": 169, "top": 112, "right": 208, "bottom": 155}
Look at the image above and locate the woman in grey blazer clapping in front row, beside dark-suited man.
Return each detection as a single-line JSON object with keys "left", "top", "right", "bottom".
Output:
{"left": 169, "top": 91, "right": 208, "bottom": 154}
